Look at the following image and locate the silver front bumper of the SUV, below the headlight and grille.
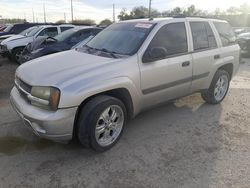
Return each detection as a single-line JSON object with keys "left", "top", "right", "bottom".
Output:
{"left": 10, "top": 87, "right": 77, "bottom": 141}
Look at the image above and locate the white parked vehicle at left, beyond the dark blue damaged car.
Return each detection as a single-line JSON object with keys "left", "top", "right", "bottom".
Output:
{"left": 0, "top": 25, "right": 74, "bottom": 63}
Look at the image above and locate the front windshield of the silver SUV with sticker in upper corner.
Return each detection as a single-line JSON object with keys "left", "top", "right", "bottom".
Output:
{"left": 85, "top": 22, "right": 154, "bottom": 55}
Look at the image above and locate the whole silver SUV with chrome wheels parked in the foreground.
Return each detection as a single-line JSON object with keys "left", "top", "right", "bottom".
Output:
{"left": 10, "top": 18, "right": 240, "bottom": 151}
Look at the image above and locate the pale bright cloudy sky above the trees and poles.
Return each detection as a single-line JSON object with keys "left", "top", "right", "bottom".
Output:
{"left": 0, "top": 0, "right": 248, "bottom": 22}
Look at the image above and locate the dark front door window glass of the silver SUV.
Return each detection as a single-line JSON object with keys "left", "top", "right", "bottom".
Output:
{"left": 145, "top": 23, "right": 188, "bottom": 58}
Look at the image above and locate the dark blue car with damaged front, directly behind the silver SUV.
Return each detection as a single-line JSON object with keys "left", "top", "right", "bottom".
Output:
{"left": 20, "top": 27, "right": 102, "bottom": 63}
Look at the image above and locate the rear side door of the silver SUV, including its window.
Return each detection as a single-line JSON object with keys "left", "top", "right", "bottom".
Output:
{"left": 189, "top": 21, "right": 221, "bottom": 92}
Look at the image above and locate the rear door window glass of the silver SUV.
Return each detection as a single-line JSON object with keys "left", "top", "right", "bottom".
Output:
{"left": 190, "top": 22, "right": 217, "bottom": 51}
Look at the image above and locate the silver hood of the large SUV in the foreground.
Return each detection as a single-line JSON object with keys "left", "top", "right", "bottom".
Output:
{"left": 16, "top": 50, "right": 120, "bottom": 88}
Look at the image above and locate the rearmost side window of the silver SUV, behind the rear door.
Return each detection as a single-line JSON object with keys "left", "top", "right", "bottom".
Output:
{"left": 214, "top": 22, "right": 236, "bottom": 46}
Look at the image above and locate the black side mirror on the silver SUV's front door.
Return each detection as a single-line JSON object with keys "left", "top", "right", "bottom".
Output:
{"left": 142, "top": 47, "right": 167, "bottom": 63}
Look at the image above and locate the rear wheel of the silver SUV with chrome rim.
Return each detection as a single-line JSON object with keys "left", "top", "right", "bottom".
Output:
{"left": 201, "top": 70, "right": 230, "bottom": 104}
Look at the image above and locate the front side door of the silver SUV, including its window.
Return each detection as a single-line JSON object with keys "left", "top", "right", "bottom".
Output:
{"left": 140, "top": 22, "right": 192, "bottom": 105}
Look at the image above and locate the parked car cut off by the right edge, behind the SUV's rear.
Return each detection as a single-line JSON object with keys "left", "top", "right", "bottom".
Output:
{"left": 237, "top": 32, "right": 250, "bottom": 57}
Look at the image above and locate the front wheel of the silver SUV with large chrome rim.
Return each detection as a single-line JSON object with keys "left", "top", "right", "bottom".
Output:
{"left": 76, "top": 95, "right": 127, "bottom": 152}
